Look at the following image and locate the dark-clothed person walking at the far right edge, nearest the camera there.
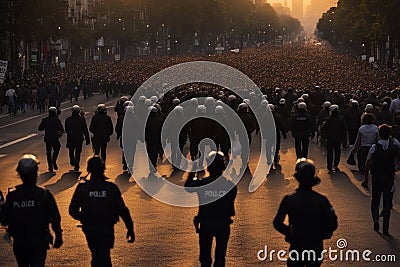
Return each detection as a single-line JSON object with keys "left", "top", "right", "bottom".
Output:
{"left": 362, "top": 124, "right": 400, "bottom": 235}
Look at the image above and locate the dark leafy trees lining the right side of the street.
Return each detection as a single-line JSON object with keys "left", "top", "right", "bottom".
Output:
{"left": 317, "top": 0, "right": 400, "bottom": 66}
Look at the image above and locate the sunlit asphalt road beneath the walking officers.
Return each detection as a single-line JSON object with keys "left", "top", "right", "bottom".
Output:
{"left": 0, "top": 95, "right": 400, "bottom": 266}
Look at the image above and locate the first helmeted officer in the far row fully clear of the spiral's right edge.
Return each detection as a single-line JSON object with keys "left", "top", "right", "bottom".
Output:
{"left": 289, "top": 102, "right": 315, "bottom": 159}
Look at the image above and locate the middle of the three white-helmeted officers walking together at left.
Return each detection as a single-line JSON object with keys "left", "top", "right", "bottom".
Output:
{"left": 65, "top": 105, "right": 90, "bottom": 172}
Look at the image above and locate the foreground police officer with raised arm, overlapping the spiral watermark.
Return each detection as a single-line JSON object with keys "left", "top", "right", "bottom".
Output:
{"left": 185, "top": 151, "right": 237, "bottom": 267}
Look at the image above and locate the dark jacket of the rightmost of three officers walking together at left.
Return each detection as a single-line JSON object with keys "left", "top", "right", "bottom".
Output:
{"left": 89, "top": 113, "right": 114, "bottom": 142}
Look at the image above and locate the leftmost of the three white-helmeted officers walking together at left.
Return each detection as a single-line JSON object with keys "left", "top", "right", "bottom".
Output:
{"left": 38, "top": 107, "right": 64, "bottom": 172}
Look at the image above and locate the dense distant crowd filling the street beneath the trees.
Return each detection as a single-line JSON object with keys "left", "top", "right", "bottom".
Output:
{"left": 0, "top": 42, "right": 400, "bottom": 114}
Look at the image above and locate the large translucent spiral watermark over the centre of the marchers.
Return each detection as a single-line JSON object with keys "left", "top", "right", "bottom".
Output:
{"left": 122, "top": 61, "right": 276, "bottom": 207}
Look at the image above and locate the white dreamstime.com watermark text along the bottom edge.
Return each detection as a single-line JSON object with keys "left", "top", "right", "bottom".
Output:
{"left": 257, "top": 238, "right": 397, "bottom": 262}
